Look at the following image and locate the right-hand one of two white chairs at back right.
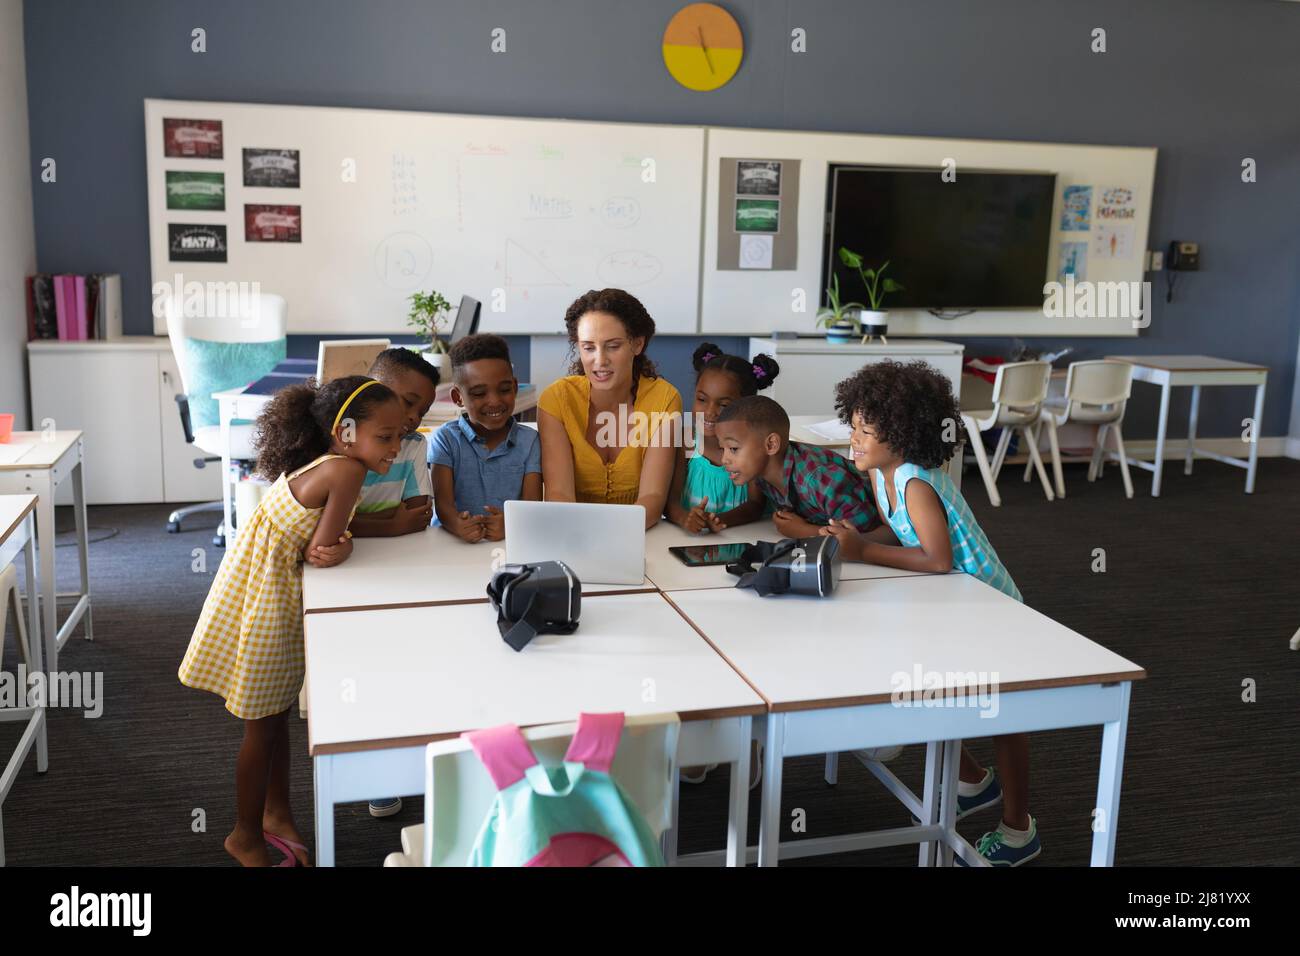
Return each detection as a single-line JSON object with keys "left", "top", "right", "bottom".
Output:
{"left": 1024, "top": 359, "right": 1134, "bottom": 498}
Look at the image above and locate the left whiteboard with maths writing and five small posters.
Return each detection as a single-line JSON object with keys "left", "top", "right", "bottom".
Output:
{"left": 144, "top": 99, "right": 705, "bottom": 334}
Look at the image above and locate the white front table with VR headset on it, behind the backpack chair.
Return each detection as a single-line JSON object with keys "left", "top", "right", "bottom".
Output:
{"left": 304, "top": 593, "right": 766, "bottom": 866}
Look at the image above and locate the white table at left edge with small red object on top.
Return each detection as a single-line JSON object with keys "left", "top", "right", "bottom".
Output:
{"left": 0, "top": 434, "right": 92, "bottom": 674}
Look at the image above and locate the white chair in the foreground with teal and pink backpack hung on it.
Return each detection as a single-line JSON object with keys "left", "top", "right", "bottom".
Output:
{"left": 384, "top": 714, "right": 681, "bottom": 866}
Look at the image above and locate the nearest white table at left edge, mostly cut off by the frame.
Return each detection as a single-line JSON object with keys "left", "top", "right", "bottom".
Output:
{"left": 0, "top": 494, "right": 49, "bottom": 866}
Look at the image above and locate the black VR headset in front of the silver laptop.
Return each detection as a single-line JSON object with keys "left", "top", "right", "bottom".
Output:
{"left": 488, "top": 561, "right": 582, "bottom": 650}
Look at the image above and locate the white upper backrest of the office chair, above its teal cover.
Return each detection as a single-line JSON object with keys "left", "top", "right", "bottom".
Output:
{"left": 163, "top": 293, "right": 289, "bottom": 393}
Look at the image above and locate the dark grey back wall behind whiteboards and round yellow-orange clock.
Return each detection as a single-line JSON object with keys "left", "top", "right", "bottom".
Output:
{"left": 25, "top": 0, "right": 1300, "bottom": 437}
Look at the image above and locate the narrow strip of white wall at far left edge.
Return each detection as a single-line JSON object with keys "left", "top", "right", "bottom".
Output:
{"left": 0, "top": 0, "right": 36, "bottom": 428}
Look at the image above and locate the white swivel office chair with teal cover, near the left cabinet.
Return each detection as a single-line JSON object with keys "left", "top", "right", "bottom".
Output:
{"left": 164, "top": 293, "right": 289, "bottom": 546}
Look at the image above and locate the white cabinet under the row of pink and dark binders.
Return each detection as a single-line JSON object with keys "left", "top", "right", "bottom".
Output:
{"left": 27, "top": 336, "right": 221, "bottom": 505}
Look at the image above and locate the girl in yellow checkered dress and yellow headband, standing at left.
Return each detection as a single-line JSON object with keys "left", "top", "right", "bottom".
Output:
{"left": 179, "top": 376, "right": 404, "bottom": 866}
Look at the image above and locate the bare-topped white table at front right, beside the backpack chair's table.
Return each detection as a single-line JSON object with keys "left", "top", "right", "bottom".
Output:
{"left": 672, "top": 572, "right": 1145, "bottom": 866}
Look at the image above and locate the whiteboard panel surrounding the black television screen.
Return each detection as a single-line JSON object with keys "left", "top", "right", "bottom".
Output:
{"left": 701, "top": 127, "right": 1156, "bottom": 337}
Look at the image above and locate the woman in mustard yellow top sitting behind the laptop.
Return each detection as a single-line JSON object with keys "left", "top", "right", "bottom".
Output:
{"left": 537, "top": 289, "right": 681, "bottom": 528}
